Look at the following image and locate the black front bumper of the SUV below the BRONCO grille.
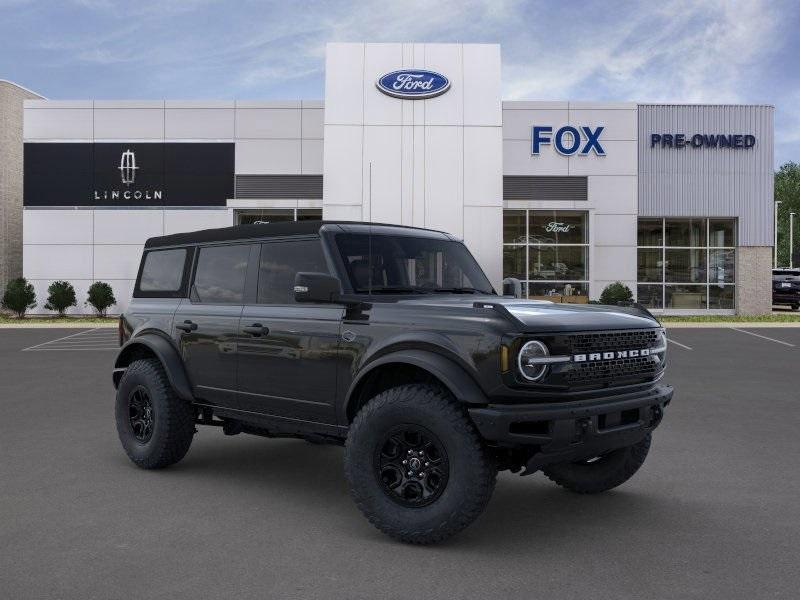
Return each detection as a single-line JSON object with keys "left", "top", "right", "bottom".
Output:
{"left": 469, "top": 384, "right": 673, "bottom": 473}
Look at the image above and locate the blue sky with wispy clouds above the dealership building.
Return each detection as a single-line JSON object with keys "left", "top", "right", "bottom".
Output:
{"left": 0, "top": 0, "right": 800, "bottom": 165}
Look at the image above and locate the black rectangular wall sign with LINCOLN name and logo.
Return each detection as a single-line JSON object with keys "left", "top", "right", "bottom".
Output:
{"left": 23, "top": 143, "right": 234, "bottom": 206}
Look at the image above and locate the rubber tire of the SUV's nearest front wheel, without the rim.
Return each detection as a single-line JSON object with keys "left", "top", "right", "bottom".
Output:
{"left": 344, "top": 384, "right": 497, "bottom": 544}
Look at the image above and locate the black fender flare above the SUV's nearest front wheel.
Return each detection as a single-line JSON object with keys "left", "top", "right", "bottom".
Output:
{"left": 344, "top": 350, "right": 488, "bottom": 414}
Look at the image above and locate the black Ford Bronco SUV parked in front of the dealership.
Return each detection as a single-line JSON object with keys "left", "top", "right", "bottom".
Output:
{"left": 113, "top": 221, "right": 672, "bottom": 544}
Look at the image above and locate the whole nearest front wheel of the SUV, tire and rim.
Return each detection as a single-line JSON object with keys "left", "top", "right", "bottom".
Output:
{"left": 345, "top": 384, "right": 497, "bottom": 544}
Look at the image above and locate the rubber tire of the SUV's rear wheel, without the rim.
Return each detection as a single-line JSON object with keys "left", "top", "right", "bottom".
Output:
{"left": 115, "top": 359, "right": 195, "bottom": 469}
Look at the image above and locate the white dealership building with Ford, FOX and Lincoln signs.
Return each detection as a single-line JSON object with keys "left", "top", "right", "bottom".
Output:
{"left": 0, "top": 43, "right": 773, "bottom": 314}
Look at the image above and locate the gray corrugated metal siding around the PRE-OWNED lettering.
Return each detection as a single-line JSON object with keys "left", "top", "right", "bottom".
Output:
{"left": 639, "top": 104, "right": 774, "bottom": 246}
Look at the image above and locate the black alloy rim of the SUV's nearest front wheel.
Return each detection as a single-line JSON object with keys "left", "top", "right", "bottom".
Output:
{"left": 374, "top": 424, "right": 450, "bottom": 508}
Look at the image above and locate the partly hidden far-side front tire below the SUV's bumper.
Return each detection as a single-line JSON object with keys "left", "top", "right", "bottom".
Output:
{"left": 542, "top": 433, "right": 651, "bottom": 494}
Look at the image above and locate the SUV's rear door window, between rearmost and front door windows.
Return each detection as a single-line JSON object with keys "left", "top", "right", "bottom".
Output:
{"left": 192, "top": 244, "right": 250, "bottom": 304}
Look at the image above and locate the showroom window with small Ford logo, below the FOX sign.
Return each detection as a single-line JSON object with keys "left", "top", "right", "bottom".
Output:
{"left": 503, "top": 210, "right": 589, "bottom": 303}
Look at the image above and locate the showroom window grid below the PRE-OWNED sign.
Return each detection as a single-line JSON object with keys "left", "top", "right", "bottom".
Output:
{"left": 637, "top": 218, "right": 736, "bottom": 310}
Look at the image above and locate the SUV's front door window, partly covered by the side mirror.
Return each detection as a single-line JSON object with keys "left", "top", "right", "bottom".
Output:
{"left": 258, "top": 239, "right": 329, "bottom": 304}
